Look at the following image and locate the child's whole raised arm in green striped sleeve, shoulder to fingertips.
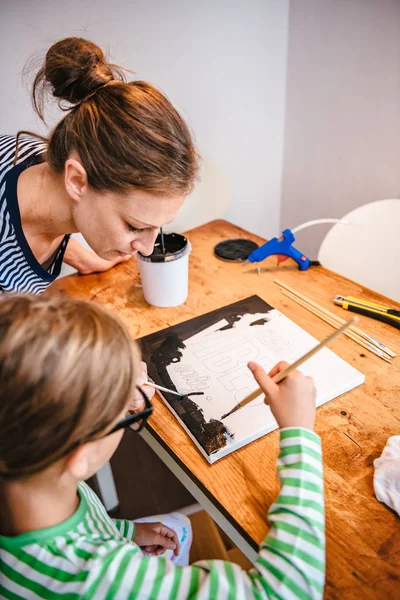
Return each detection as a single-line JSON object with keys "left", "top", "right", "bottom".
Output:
{"left": 87, "top": 364, "right": 325, "bottom": 600}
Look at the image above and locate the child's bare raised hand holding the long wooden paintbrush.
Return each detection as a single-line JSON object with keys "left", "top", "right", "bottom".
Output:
{"left": 248, "top": 361, "right": 317, "bottom": 430}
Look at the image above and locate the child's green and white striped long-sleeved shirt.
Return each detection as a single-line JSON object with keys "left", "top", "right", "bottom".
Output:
{"left": 0, "top": 428, "right": 325, "bottom": 600}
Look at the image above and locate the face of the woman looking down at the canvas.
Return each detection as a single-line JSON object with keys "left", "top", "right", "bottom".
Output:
{"left": 72, "top": 188, "right": 185, "bottom": 260}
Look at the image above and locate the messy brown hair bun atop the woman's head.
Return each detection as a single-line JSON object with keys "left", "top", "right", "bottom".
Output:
{"left": 43, "top": 37, "right": 120, "bottom": 104}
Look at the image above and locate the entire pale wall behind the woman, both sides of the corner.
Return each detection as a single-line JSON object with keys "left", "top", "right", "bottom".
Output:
{"left": 0, "top": 0, "right": 400, "bottom": 258}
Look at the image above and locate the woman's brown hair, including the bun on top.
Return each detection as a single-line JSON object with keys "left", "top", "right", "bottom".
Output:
{"left": 17, "top": 37, "right": 198, "bottom": 195}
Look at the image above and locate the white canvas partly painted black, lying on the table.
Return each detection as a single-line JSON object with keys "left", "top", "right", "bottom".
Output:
{"left": 140, "top": 296, "right": 364, "bottom": 463}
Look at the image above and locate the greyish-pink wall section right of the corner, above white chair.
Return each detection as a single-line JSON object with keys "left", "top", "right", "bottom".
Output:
{"left": 281, "top": 0, "right": 400, "bottom": 258}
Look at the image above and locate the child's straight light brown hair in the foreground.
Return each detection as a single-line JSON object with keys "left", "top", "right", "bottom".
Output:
{"left": 0, "top": 296, "right": 139, "bottom": 481}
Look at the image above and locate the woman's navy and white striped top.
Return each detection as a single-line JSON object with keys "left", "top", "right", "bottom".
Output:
{"left": 0, "top": 135, "right": 69, "bottom": 294}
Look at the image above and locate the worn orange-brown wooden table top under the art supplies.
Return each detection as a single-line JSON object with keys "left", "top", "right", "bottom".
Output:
{"left": 49, "top": 221, "right": 400, "bottom": 600}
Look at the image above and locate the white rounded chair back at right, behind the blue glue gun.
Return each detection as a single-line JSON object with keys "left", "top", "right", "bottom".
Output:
{"left": 318, "top": 199, "right": 400, "bottom": 302}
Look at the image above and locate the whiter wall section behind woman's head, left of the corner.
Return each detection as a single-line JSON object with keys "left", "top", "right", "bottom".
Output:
{"left": 0, "top": 0, "right": 289, "bottom": 241}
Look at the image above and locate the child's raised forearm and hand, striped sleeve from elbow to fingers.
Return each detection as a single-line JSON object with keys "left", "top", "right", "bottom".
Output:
{"left": 249, "top": 363, "right": 325, "bottom": 600}
